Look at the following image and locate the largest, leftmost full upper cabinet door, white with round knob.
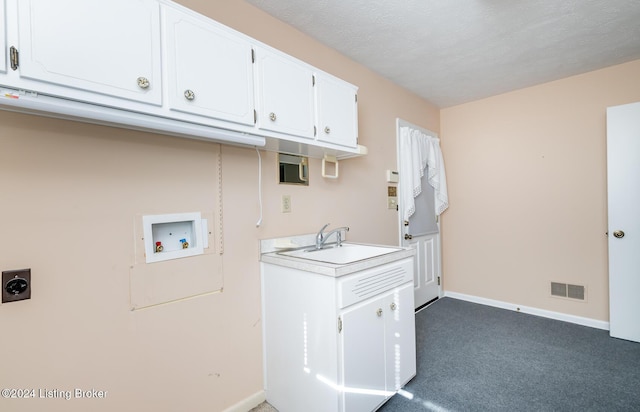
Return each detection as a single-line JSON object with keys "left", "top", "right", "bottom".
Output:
{"left": 18, "top": 0, "right": 162, "bottom": 105}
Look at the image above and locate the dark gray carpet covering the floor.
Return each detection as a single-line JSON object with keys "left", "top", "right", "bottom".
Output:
{"left": 379, "top": 298, "right": 640, "bottom": 412}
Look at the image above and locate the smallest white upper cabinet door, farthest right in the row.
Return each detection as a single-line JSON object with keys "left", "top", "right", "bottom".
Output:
{"left": 315, "top": 74, "right": 358, "bottom": 147}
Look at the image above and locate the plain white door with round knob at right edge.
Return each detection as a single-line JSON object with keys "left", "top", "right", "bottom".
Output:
{"left": 607, "top": 102, "right": 640, "bottom": 342}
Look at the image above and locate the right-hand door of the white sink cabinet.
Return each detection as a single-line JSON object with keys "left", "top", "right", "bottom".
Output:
{"left": 383, "top": 283, "right": 416, "bottom": 392}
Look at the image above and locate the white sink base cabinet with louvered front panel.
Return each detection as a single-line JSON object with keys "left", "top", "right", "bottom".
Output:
{"left": 262, "top": 257, "right": 416, "bottom": 412}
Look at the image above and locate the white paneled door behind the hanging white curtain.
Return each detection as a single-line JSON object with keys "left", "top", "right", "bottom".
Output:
{"left": 398, "top": 120, "right": 440, "bottom": 308}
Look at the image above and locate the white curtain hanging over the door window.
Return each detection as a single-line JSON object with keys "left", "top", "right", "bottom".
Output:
{"left": 400, "top": 127, "right": 449, "bottom": 220}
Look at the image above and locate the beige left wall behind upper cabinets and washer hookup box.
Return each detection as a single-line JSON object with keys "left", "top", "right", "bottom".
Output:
{"left": 0, "top": 0, "right": 439, "bottom": 412}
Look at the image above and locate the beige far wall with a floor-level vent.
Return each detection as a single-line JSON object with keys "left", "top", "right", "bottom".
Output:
{"left": 441, "top": 61, "right": 640, "bottom": 321}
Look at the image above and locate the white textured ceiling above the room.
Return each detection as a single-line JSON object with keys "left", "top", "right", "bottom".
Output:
{"left": 247, "top": 0, "right": 640, "bottom": 107}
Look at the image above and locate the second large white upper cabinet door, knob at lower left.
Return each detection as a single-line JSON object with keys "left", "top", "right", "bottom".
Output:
{"left": 164, "top": 7, "right": 254, "bottom": 125}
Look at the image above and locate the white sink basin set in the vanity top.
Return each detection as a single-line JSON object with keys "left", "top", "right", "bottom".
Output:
{"left": 279, "top": 243, "right": 402, "bottom": 265}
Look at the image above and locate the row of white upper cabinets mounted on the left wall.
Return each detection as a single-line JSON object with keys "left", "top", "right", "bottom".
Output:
{"left": 0, "top": 0, "right": 366, "bottom": 158}
